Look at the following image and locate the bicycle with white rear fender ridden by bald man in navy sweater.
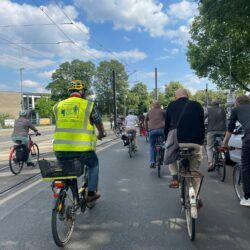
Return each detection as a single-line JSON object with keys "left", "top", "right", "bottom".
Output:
{"left": 178, "top": 147, "right": 204, "bottom": 241}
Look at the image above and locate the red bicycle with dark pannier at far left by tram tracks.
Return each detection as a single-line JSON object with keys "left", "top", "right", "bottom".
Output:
{"left": 9, "top": 134, "right": 40, "bottom": 175}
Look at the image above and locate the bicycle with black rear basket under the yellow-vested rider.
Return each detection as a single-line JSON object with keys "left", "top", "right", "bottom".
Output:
{"left": 39, "top": 158, "right": 95, "bottom": 247}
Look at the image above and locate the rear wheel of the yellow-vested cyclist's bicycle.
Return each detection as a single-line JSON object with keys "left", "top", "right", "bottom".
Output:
{"left": 51, "top": 188, "right": 75, "bottom": 247}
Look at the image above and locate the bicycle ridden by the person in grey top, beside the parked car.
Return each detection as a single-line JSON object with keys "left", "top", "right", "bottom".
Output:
{"left": 212, "top": 134, "right": 226, "bottom": 182}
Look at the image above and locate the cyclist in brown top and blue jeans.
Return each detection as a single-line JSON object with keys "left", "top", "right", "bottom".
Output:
{"left": 145, "top": 101, "right": 166, "bottom": 168}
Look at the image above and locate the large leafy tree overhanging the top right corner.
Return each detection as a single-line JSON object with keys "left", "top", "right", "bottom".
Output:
{"left": 187, "top": 0, "right": 250, "bottom": 91}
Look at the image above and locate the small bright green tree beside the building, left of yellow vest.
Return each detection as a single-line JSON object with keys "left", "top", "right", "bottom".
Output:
{"left": 36, "top": 96, "right": 56, "bottom": 118}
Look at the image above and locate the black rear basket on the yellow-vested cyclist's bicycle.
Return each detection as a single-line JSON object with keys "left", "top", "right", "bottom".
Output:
{"left": 38, "top": 159, "right": 83, "bottom": 178}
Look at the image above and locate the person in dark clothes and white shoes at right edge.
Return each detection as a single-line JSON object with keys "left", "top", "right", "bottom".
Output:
{"left": 223, "top": 95, "right": 250, "bottom": 206}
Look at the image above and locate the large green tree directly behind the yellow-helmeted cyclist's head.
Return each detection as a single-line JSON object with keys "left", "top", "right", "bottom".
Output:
{"left": 46, "top": 60, "right": 95, "bottom": 101}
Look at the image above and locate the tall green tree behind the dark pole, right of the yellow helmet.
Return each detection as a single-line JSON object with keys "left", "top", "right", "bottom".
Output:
{"left": 94, "top": 60, "right": 128, "bottom": 114}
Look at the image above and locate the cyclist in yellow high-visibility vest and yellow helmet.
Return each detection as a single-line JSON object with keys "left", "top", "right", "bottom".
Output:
{"left": 53, "top": 80, "right": 105, "bottom": 202}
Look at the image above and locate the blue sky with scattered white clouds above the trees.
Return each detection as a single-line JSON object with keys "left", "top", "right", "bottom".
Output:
{"left": 0, "top": 0, "right": 213, "bottom": 92}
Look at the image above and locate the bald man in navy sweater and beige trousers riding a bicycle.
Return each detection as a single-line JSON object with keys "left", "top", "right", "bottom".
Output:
{"left": 165, "top": 89, "right": 205, "bottom": 192}
